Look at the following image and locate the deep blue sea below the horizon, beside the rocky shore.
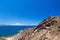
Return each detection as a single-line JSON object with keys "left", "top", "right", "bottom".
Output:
{"left": 0, "top": 26, "right": 34, "bottom": 36}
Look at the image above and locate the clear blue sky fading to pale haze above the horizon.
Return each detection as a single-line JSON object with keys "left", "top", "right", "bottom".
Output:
{"left": 0, "top": 0, "right": 60, "bottom": 25}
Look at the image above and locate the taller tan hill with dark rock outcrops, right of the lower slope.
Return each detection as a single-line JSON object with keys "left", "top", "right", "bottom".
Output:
{"left": 31, "top": 16, "right": 60, "bottom": 40}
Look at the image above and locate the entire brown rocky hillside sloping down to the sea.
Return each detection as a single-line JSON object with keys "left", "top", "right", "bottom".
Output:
{"left": 4, "top": 16, "right": 60, "bottom": 40}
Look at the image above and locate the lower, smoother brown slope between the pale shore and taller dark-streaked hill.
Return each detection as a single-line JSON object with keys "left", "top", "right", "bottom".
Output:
{"left": 18, "top": 28, "right": 34, "bottom": 40}
